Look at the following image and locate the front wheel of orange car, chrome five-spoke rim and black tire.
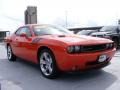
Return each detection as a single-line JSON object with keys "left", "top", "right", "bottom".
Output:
{"left": 39, "top": 49, "right": 58, "bottom": 79}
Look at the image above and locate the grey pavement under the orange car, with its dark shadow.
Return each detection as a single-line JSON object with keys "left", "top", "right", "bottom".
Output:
{"left": 0, "top": 44, "right": 120, "bottom": 90}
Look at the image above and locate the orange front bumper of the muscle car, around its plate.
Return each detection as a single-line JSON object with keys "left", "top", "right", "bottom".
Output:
{"left": 57, "top": 48, "right": 116, "bottom": 71}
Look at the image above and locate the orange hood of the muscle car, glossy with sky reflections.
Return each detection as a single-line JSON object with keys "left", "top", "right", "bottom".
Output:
{"left": 39, "top": 35, "right": 112, "bottom": 45}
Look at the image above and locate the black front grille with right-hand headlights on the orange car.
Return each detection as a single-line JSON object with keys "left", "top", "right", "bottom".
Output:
{"left": 81, "top": 43, "right": 114, "bottom": 52}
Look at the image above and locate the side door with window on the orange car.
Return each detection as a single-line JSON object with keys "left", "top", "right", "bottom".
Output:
{"left": 13, "top": 26, "right": 32, "bottom": 60}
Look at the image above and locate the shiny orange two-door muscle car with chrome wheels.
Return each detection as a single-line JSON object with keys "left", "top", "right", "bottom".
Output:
{"left": 5, "top": 24, "right": 116, "bottom": 78}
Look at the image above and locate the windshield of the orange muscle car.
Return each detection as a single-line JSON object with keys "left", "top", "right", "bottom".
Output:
{"left": 34, "top": 26, "right": 72, "bottom": 36}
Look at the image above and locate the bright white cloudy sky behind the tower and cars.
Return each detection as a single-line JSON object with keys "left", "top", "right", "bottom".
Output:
{"left": 0, "top": 0, "right": 120, "bottom": 31}
